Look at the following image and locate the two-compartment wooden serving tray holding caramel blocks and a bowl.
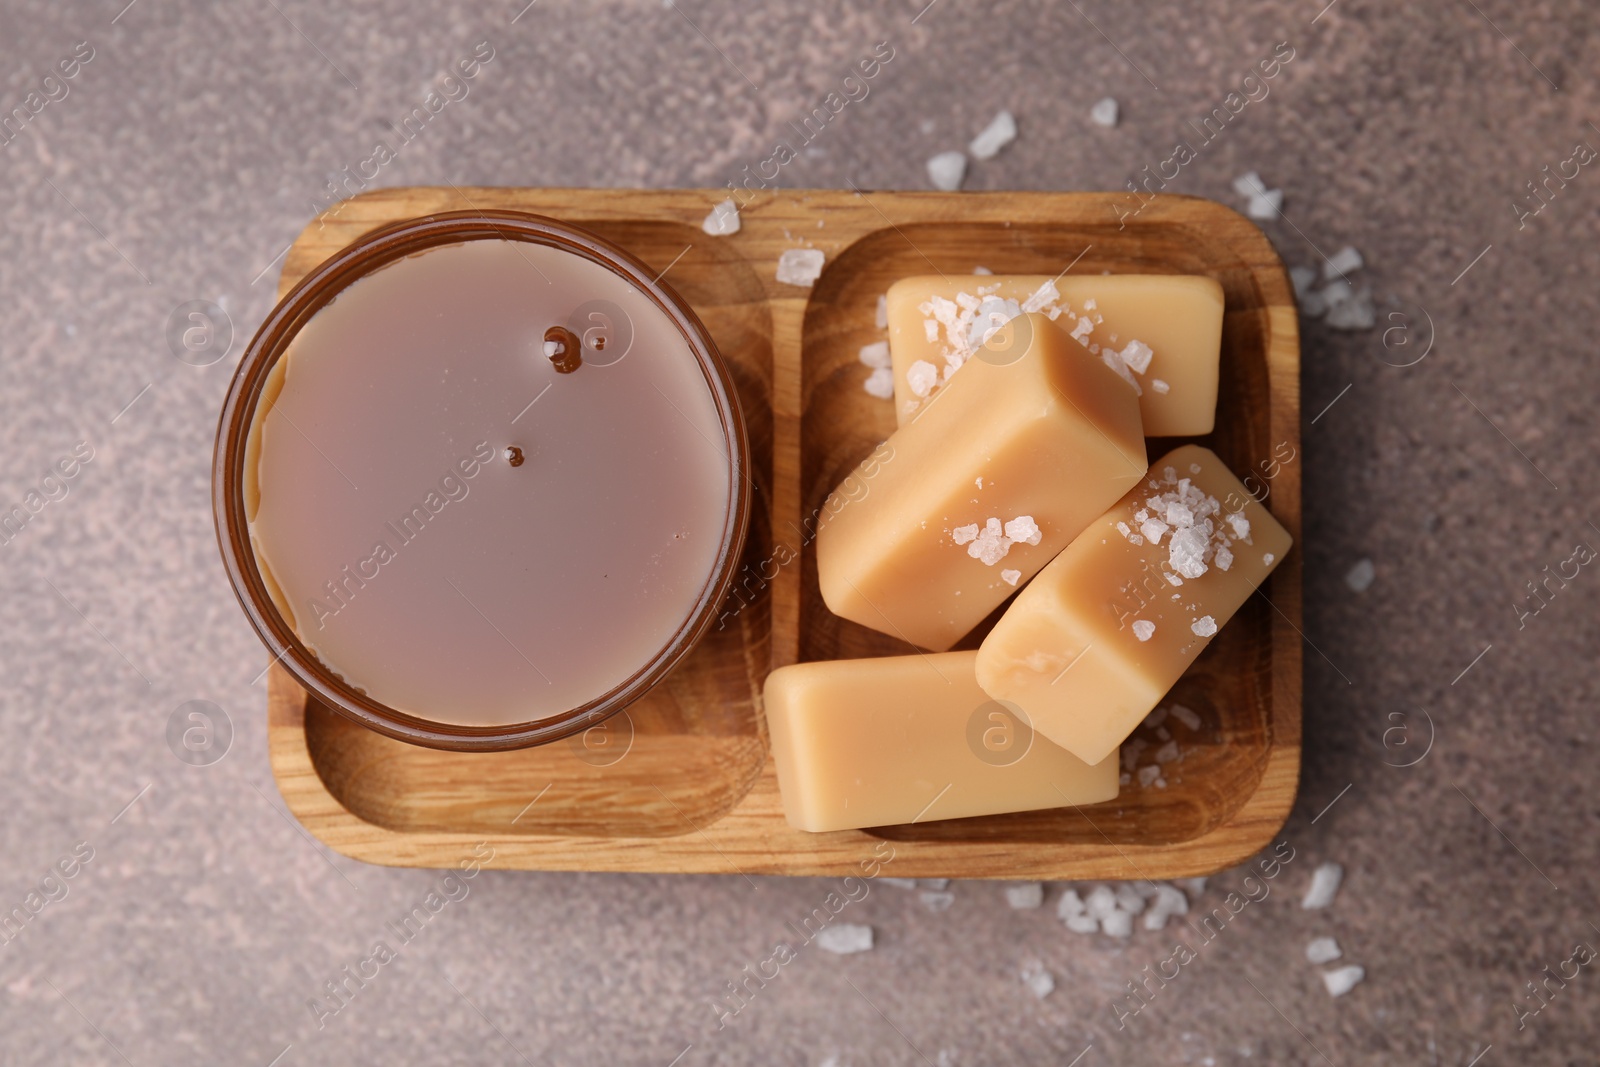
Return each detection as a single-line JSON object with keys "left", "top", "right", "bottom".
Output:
{"left": 269, "top": 186, "right": 1301, "bottom": 880}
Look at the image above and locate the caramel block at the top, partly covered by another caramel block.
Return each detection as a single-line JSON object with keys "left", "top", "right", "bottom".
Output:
{"left": 888, "top": 274, "right": 1222, "bottom": 437}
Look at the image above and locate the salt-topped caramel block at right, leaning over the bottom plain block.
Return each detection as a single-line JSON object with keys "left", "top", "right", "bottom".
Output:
{"left": 978, "top": 445, "right": 1291, "bottom": 761}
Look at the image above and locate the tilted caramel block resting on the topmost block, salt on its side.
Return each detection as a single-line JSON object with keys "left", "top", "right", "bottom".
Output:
{"left": 816, "top": 315, "right": 1146, "bottom": 651}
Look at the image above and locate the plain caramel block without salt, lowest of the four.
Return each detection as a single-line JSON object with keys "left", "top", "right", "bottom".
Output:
{"left": 765, "top": 653, "right": 1118, "bottom": 832}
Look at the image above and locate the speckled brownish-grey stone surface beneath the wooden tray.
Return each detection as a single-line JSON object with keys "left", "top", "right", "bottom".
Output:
{"left": 0, "top": 0, "right": 1600, "bottom": 1067}
